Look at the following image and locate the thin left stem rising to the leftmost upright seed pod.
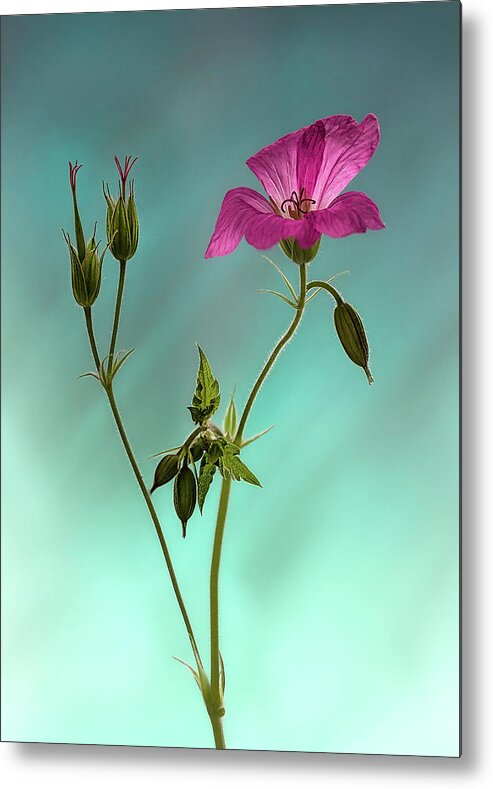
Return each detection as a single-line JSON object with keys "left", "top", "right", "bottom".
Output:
{"left": 84, "top": 308, "right": 201, "bottom": 662}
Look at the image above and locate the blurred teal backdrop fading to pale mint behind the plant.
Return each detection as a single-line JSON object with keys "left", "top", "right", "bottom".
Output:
{"left": 2, "top": 2, "right": 460, "bottom": 756}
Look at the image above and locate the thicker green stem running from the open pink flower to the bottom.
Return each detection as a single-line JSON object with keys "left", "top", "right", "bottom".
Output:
{"left": 210, "top": 264, "right": 306, "bottom": 748}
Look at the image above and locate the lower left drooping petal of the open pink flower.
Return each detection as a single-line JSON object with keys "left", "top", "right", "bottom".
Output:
{"left": 205, "top": 186, "right": 304, "bottom": 258}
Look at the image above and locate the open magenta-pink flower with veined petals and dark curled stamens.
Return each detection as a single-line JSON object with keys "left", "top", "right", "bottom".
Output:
{"left": 205, "top": 114, "right": 385, "bottom": 258}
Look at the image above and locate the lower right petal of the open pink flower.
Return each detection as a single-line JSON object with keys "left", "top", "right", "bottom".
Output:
{"left": 309, "top": 192, "right": 385, "bottom": 238}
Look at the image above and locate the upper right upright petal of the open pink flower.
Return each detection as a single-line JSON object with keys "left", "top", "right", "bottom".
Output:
{"left": 308, "top": 114, "right": 380, "bottom": 210}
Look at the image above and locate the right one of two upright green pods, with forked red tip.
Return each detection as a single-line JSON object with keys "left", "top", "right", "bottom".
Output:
{"left": 103, "top": 156, "right": 139, "bottom": 261}
